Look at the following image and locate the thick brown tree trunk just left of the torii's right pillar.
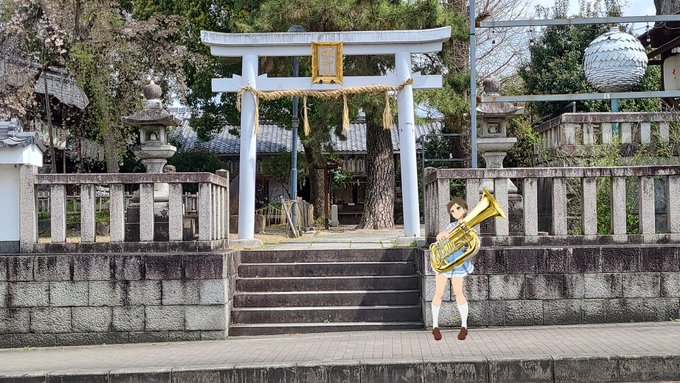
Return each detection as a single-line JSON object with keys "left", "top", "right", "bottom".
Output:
{"left": 357, "top": 115, "right": 395, "bottom": 229}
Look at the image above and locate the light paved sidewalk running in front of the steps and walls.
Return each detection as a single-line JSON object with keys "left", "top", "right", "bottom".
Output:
{"left": 0, "top": 322, "right": 680, "bottom": 381}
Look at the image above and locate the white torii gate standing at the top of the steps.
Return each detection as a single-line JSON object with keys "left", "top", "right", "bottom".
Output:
{"left": 201, "top": 27, "right": 451, "bottom": 242}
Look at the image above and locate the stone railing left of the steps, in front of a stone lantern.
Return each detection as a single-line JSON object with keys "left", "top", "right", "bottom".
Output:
{"left": 20, "top": 171, "right": 229, "bottom": 252}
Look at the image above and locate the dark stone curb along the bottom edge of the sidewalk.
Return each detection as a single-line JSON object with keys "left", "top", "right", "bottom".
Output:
{"left": 0, "top": 354, "right": 680, "bottom": 383}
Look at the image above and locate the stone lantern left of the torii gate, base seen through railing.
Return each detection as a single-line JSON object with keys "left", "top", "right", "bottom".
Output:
{"left": 122, "top": 81, "right": 181, "bottom": 241}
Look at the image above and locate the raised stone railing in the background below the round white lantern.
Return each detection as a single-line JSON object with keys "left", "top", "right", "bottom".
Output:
{"left": 536, "top": 112, "right": 680, "bottom": 161}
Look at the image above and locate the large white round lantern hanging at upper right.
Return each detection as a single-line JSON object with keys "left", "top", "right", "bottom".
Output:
{"left": 583, "top": 27, "right": 647, "bottom": 92}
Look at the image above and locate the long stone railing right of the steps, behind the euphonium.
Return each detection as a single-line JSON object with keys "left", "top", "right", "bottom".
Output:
{"left": 424, "top": 166, "right": 680, "bottom": 246}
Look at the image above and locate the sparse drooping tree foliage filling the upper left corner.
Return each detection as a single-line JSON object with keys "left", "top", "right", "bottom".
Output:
{"left": 0, "top": 0, "right": 196, "bottom": 172}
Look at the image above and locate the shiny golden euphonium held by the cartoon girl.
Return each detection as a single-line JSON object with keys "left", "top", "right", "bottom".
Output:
{"left": 430, "top": 189, "right": 507, "bottom": 273}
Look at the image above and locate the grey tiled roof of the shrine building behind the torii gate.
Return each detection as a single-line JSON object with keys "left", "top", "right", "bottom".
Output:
{"left": 170, "top": 120, "right": 442, "bottom": 154}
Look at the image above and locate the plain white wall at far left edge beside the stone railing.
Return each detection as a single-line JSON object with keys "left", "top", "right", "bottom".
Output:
{"left": 0, "top": 166, "right": 20, "bottom": 241}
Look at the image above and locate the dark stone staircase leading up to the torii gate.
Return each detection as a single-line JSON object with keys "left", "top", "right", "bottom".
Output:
{"left": 229, "top": 249, "right": 422, "bottom": 335}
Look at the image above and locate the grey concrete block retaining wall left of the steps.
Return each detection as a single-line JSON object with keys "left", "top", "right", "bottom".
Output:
{"left": 0, "top": 252, "right": 239, "bottom": 348}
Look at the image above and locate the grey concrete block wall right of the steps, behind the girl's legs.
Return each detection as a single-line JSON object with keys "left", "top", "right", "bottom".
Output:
{"left": 419, "top": 245, "right": 680, "bottom": 328}
